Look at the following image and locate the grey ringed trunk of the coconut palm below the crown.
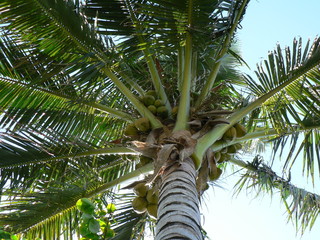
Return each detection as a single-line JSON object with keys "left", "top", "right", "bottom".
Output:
{"left": 156, "top": 158, "right": 203, "bottom": 240}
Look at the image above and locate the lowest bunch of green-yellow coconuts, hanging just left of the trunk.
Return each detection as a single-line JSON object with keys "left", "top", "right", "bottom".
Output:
{"left": 132, "top": 182, "right": 159, "bottom": 219}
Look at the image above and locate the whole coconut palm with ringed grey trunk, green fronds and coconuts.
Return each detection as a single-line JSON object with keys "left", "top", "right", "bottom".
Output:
{"left": 0, "top": 0, "right": 320, "bottom": 239}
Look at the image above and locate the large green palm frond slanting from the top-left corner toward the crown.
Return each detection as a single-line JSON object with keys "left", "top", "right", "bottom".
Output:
{"left": 0, "top": 1, "right": 140, "bottom": 124}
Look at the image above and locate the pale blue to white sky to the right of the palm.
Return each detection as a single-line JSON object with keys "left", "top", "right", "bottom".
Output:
{"left": 202, "top": 0, "right": 320, "bottom": 240}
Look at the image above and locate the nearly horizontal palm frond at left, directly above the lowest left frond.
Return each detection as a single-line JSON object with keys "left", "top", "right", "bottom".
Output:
{"left": 0, "top": 126, "right": 138, "bottom": 192}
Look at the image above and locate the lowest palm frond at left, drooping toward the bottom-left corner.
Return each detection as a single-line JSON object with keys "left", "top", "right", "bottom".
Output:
{"left": 0, "top": 158, "right": 139, "bottom": 236}
